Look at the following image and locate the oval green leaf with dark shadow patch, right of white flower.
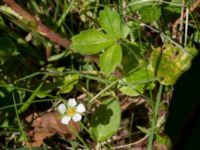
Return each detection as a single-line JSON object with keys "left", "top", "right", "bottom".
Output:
{"left": 90, "top": 99, "right": 121, "bottom": 142}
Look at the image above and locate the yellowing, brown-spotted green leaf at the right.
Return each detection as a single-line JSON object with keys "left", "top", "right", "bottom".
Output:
{"left": 150, "top": 44, "right": 196, "bottom": 85}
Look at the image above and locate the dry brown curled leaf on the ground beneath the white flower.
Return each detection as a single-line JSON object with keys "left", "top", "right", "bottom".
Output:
{"left": 25, "top": 111, "right": 80, "bottom": 147}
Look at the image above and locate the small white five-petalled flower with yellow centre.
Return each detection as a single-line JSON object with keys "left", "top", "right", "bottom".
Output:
{"left": 58, "top": 98, "right": 86, "bottom": 124}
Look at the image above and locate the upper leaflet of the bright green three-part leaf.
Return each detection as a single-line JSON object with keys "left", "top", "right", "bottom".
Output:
{"left": 98, "top": 7, "right": 123, "bottom": 39}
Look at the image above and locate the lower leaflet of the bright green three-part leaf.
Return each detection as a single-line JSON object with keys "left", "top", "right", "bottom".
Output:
{"left": 100, "top": 44, "right": 122, "bottom": 75}
